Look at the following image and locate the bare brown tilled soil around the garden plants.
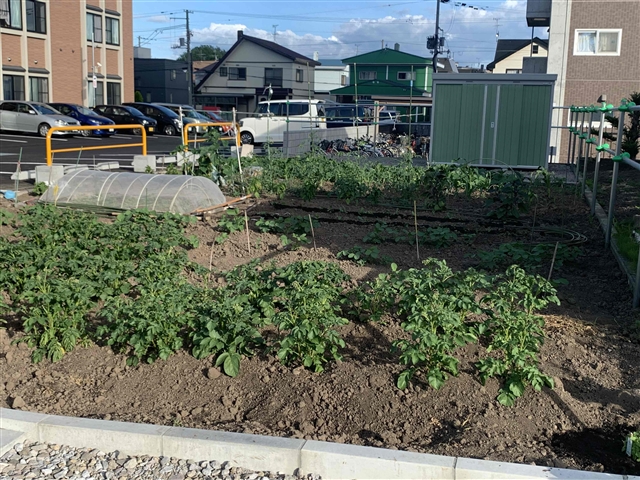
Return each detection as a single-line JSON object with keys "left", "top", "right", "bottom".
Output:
{"left": 0, "top": 191, "right": 640, "bottom": 474}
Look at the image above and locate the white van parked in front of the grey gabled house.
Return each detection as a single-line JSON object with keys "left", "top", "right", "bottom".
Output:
{"left": 240, "top": 100, "right": 327, "bottom": 144}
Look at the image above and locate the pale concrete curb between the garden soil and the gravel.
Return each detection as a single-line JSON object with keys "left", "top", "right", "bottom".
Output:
{"left": 0, "top": 408, "right": 640, "bottom": 480}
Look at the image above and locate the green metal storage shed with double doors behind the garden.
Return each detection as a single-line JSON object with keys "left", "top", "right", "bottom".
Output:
{"left": 430, "top": 73, "right": 556, "bottom": 168}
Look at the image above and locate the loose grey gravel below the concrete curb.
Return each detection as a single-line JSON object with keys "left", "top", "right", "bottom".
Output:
{"left": 0, "top": 443, "right": 320, "bottom": 480}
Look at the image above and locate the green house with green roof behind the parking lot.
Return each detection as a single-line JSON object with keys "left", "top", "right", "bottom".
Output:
{"left": 331, "top": 43, "right": 433, "bottom": 104}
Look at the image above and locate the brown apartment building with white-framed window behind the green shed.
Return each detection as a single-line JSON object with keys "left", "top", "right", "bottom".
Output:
{"left": 527, "top": 0, "right": 640, "bottom": 159}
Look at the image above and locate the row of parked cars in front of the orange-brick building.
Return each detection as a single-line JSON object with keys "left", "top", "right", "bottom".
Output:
{"left": 0, "top": 100, "right": 230, "bottom": 137}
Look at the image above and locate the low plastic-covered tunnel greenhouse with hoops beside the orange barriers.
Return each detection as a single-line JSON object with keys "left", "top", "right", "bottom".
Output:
{"left": 40, "top": 170, "right": 225, "bottom": 214}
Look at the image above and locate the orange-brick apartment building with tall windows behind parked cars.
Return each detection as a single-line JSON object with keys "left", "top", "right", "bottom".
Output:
{"left": 0, "top": 0, "right": 134, "bottom": 106}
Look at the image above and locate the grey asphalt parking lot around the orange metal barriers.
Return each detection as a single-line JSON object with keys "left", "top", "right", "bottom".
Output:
{"left": 0, "top": 132, "right": 181, "bottom": 189}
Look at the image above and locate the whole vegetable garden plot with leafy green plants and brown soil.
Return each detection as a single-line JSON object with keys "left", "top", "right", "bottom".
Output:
{"left": 0, "top": 160, "right": 638, "bottom": 473}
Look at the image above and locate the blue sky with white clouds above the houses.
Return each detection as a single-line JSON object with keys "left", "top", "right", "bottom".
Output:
{"left": 133, "top": 0, "right": 548, "bottom": 66}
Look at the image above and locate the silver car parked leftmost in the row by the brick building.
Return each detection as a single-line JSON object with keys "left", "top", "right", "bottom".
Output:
{"left": 0, "top": 100, "right": 80, "bottom": 137}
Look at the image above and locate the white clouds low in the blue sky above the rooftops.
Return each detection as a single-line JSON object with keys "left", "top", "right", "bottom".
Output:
{"left": 186, "top": 0, "right": 528, "bottom": 64}
